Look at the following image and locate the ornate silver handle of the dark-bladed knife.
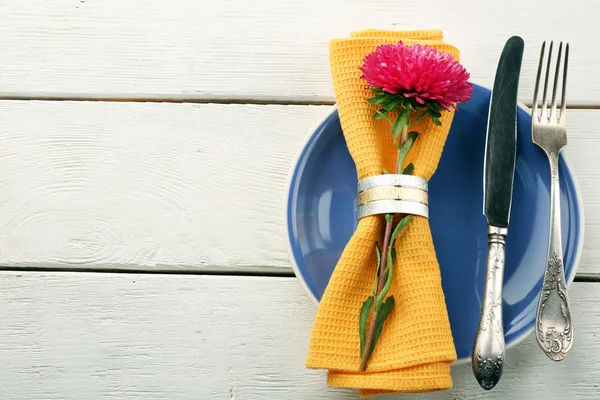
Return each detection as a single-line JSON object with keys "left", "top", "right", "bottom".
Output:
{"left": 472, "top": 226, "right": 508, "bottom": 390}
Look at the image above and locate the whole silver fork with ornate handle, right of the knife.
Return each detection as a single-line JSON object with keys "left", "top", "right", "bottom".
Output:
{"left": 531, "top": 42, "right": 573, "bottom": 361}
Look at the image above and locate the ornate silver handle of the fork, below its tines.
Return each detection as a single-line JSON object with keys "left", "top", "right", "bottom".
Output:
{"left": 536, "top": 152, "right": 573, "bottom": 361}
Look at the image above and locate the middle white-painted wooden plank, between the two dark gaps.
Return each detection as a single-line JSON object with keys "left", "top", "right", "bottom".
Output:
{"left": 0, "top": 101, "right": 600, "bottom": 272}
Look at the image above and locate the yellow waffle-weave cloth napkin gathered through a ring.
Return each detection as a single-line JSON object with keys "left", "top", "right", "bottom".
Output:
{"left": 306, "top": 30, "right": 459, "bottom": 396}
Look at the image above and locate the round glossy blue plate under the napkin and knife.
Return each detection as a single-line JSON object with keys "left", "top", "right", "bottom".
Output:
{"left": 286, "top": 85, "right": 583, "bottom": 361}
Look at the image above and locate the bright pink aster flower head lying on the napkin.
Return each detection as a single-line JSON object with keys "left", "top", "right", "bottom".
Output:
{"left": 360, "top": 42, "right": 473, "bottom": 110}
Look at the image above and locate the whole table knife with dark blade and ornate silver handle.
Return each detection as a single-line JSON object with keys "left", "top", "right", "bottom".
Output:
{"left": 472, "top": 36, "right": 524, "bottom": 390}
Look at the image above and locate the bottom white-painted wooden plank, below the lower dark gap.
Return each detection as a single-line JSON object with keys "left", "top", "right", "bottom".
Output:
{"left": 0, "top": 272, "right": 600, "bottom": 400}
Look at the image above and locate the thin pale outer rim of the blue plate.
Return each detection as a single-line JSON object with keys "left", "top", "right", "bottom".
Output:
{"left": 283, "top": 84, "right": 585, "bottom": 366}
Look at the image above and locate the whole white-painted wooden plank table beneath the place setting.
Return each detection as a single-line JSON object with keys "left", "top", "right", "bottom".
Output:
{"left": 0, "top": 0, "right": 600, "bottom": 400}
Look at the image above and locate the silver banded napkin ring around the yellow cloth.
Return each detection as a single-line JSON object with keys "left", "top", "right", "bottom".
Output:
{"left": 358, "top": 174, "right": 429, "bottom": 219}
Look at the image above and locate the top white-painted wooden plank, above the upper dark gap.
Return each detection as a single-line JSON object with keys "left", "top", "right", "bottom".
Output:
{"left": 0, "top": 0, "right": 600, "bottom": 105}
